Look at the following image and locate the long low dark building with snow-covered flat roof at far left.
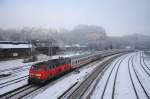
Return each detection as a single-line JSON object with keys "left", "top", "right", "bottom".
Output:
{"left": 0, "top": 41, "right": 32, "bottom": 60}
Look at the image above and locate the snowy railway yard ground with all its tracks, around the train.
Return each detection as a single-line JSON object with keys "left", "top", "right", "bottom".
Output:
{"left": 0, "top": 51, "right": 150, "bottom": 99}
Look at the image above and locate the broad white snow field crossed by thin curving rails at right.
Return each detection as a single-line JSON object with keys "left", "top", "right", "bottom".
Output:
{"left": 91, "top": 52, "right": 150, "bottom": 99}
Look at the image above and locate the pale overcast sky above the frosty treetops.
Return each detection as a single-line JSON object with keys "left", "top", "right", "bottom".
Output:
{"left": 0, "top": 0, "right": 150, "bottom": 36}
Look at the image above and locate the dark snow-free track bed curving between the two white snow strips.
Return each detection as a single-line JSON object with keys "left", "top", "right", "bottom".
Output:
{"left": 58, "top": 54, "right": 125, "bottom": 99}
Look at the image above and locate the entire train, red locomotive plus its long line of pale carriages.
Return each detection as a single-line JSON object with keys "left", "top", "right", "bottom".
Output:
{"left": 28, "top": 50, "right": 131, "bottom": 83}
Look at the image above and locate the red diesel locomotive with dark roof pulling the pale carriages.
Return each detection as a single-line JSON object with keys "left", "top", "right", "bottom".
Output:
{"left": 28, "top": 58, "right": 71, "bottom": 83}
